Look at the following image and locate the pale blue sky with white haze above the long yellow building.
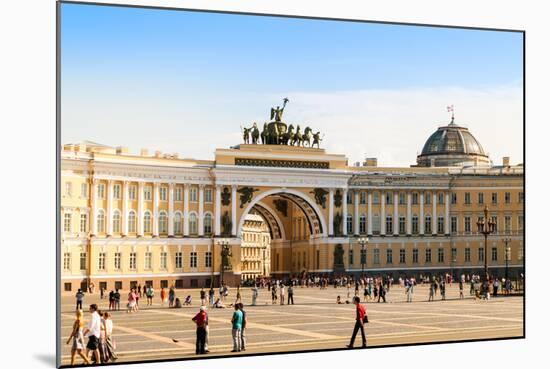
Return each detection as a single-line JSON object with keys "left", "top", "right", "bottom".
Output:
{"left": 62, "top": 4, "right": 523, "bottom": 166}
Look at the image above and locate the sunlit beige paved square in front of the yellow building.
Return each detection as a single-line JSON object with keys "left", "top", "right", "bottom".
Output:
{"left": 61, "top": 284, "right": 523, "bottom": 365}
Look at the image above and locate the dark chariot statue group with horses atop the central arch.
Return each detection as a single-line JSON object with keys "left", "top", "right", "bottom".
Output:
{"left": 242, "top": 97, "right": 324, "bottom": 148}
